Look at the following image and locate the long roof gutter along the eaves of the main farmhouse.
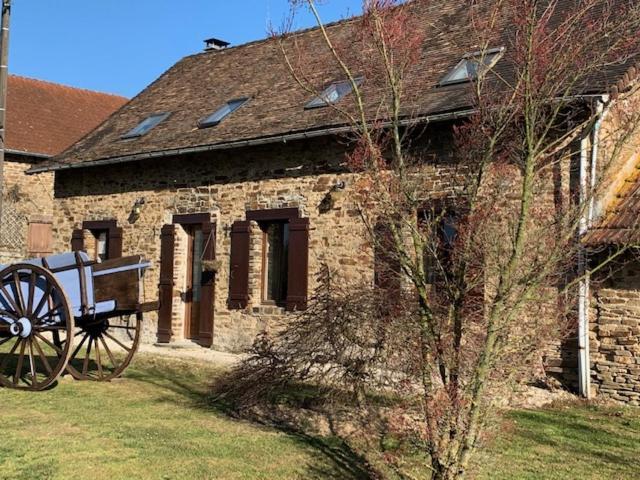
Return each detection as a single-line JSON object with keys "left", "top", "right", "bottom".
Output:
{"left": 27, "top": 109, "right": 475, "bottom": 175}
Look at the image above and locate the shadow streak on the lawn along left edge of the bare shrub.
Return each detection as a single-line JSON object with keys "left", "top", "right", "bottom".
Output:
{"left": 126, "top": 358, "right": 376, "bottom": 480}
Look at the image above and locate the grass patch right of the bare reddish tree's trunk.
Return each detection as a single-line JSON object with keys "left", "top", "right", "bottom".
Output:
{"left": 475, "top": 404, "right": 640, "bottom": 480}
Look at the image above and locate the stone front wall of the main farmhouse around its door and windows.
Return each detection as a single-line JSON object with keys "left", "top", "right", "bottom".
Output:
{"left": 54, "top": 139, "right": 454, "bottom": 351}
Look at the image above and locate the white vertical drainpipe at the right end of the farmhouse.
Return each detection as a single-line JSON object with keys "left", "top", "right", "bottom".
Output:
{"left": 578, "top": 96, "right": 607, "bottom": 399}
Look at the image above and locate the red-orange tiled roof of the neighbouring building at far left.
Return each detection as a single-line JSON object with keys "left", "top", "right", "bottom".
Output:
{"left": 7, "top": 75, "right": 127, "bottom": 155}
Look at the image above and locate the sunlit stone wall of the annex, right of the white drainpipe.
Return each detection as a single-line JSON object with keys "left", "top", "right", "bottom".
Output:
{"left": 590, "top": 255, "right": 640, "bottom": 405}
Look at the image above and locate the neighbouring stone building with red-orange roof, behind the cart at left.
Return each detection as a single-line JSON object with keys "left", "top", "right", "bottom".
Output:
{"left": 0, "top": 75, "right": 127, "bottom": 263}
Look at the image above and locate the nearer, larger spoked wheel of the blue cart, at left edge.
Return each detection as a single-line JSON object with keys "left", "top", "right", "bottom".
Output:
{"left": 0, "top": 264, "right": 74, "bottom": 390}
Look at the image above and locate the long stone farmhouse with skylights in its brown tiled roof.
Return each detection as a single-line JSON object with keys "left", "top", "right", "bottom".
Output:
{"left": 31, "top": 2, "right": 640, "bottom": 404}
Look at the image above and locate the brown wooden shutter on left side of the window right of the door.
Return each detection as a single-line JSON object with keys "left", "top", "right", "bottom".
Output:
{"left": 229, "top": 221, "right": 251, "bottom": 310}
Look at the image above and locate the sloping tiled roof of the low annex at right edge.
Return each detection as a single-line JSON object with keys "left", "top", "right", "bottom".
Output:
{"left": 583, "top": 165, "right": 640, "bottom": 246}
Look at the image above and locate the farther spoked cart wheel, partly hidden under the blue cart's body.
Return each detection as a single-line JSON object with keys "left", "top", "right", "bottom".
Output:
{"left": 62, "top": 313, "right": 142, "bottom": 382}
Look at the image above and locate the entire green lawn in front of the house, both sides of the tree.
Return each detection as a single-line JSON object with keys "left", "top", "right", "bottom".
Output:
{"left": 0, "top": 355, "right": 640, "bottom": 480}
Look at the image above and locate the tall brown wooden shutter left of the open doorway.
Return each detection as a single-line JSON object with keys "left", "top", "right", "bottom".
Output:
{"left": 158, "top": 225, "right": 176, "bottom": 343}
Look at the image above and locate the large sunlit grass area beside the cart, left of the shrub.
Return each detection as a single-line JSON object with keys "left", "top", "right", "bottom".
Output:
{"left": 0, "top": 355, "right": 365, "bottom": 480}
